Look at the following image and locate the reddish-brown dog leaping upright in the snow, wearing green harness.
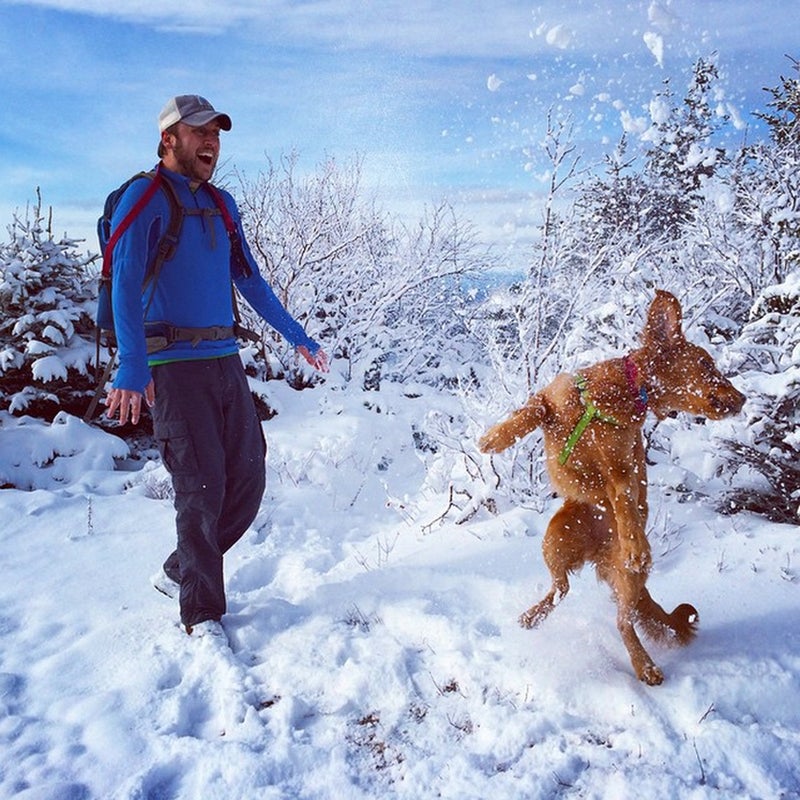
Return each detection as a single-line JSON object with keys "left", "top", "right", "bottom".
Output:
{"left": 479, "top": 291, "right": 745, "bottom": 685}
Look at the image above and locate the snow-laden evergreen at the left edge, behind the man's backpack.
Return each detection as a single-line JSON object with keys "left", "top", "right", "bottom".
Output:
{"left": 0, "top": 194, "right": 95, "bottom": 419}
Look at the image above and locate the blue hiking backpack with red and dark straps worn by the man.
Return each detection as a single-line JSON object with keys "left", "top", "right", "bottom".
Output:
{"left": 84, "top": 164, "right": 259, "bottom": 422}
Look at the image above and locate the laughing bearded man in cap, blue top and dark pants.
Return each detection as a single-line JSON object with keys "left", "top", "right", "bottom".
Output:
{"left": 106, "top": 95, "right": 328, "bottom": 636}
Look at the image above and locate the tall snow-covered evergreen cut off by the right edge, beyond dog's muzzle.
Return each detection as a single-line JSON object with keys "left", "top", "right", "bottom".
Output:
{"left": 708, "top": 59, "right": 800, "bottom": 523}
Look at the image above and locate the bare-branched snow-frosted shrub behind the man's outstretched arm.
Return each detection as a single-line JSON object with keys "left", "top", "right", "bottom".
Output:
{"left": 234, "top": 155, "right": 487, "bottom": 389}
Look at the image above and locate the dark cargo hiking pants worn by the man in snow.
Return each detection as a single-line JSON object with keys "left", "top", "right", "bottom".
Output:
{"left": 152, "top": 356, "right": 266, "bottom": 626}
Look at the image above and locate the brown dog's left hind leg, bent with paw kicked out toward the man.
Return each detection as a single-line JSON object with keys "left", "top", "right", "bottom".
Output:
{"left": 519, "top": 500, "right": 597, "bottom": 628}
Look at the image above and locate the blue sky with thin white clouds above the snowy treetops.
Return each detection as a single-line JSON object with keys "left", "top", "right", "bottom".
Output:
{"left": 0, "top": 0, "right": 800, "bottom": 266}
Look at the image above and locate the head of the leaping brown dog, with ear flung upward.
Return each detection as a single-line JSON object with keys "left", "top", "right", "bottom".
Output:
{"left": 642, "top": 290, "right": 746, "bottom": 419}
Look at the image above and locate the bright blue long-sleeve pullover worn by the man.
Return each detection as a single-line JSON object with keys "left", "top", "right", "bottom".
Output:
{"left": 111, "top": 166, "right": 319, "bottom": 392}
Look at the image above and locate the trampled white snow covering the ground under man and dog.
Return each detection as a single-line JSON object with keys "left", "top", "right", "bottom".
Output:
{"left": 0, "top": 379, "right": 800, "bottom": 800}
